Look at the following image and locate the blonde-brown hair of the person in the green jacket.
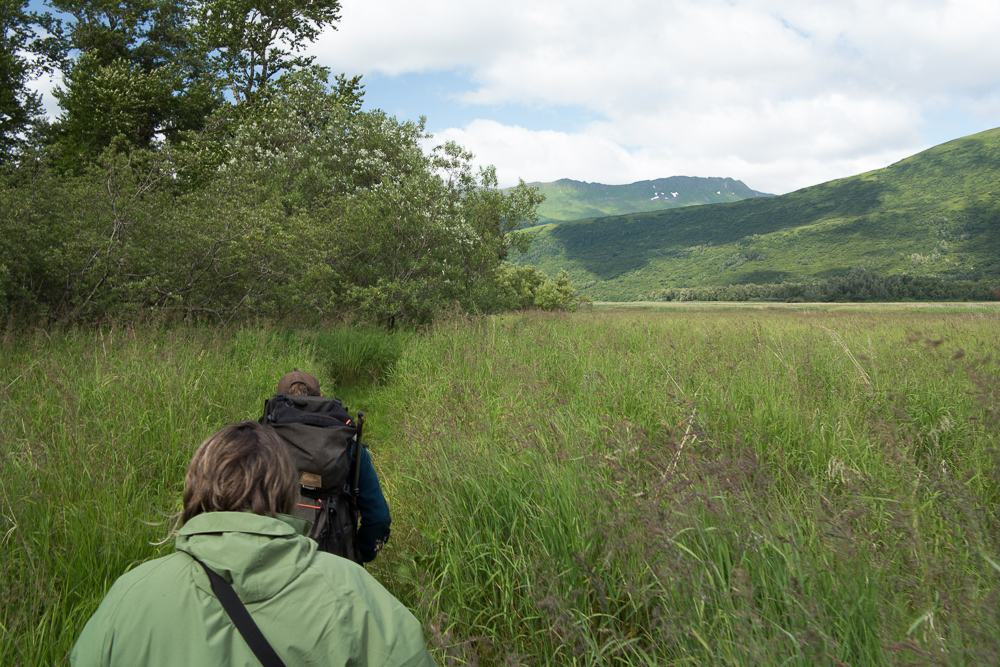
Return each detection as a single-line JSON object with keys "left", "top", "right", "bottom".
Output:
{"left": 179, "top": 421, "right": 298, "bottom": 524}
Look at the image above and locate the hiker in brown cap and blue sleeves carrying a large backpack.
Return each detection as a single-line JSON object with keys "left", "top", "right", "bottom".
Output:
{"left": 259, "top": 368, "right": 391, "bottom": 563}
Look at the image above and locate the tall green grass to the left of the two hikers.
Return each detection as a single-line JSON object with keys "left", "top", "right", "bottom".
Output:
{"left": 0, "top": 326, "right": 406, "bottom": 665}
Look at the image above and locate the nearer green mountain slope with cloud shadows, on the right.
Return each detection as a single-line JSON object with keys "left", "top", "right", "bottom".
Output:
{"left": 515, "top": 128, "right": 1000, "bottom": 301}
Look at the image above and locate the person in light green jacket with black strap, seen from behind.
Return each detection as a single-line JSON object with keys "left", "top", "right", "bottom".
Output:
{"left": 70, "top": 421, "right": 436, "bottom": 667}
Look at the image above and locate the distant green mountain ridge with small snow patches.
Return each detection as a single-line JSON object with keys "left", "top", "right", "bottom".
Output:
{"left": 531, "top": 176, "right": 770, "bottom": 222}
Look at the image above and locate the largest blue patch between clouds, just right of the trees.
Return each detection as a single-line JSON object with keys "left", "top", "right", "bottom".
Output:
{"left": 361, "top": 71, "right": 602, "bottom": 133}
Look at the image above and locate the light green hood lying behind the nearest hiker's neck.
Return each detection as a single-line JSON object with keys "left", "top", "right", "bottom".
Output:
{"left": 175, "top": 512, "right": 316, "bottom": 604}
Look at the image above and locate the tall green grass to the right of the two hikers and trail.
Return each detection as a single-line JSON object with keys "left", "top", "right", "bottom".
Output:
{"left": 377, "top": 312, "right": 1000, "bottom": 667}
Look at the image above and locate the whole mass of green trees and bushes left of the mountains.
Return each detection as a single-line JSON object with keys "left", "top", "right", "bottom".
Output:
{"left": 0, "top": 0, "right": 578, "bottom": 325}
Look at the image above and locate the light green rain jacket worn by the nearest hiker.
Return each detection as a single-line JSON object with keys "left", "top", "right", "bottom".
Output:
{"left": 70, "top": 512, "right": 436, "bottom": 667}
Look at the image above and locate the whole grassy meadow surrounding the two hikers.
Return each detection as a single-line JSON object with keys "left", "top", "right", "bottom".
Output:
{"left": 0, "top": 308, "right": 1000, "bottom": 667}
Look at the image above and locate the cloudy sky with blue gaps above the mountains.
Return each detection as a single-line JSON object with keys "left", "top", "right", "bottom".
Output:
{"left": 312, "top": 0, "right": 1000, "bottom": 194}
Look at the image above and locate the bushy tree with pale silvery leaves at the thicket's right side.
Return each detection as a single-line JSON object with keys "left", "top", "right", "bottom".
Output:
{"left": 177, "top": 68, "right": 556, "bottom": 322}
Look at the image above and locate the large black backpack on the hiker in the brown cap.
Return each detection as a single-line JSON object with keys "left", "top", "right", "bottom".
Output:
{"left": 259, "top": 394, "right": 364, "bottom": 563}
